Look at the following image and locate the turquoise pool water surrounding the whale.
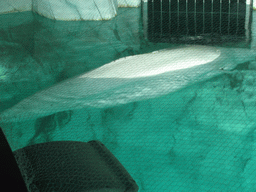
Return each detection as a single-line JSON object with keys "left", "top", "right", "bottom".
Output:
{"left": 0, "top": 8, "right": 256, "bottom": 192}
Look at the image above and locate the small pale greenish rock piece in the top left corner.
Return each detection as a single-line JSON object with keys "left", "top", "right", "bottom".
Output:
{"left": 0, "top": 0, "right": 32, "bottom": 14}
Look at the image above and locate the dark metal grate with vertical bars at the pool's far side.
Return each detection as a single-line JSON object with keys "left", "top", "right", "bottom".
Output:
{"left": 143, "top": 0, "right": 252, "bottom": 46}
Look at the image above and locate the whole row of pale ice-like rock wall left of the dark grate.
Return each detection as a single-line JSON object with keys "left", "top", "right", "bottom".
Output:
{"left": 0, "top": 0, "right": 140, "bottom": 20}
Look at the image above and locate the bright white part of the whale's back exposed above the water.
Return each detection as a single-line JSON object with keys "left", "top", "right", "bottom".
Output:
{"left": 82, "top": 46, "right": 221, "bottom": 79}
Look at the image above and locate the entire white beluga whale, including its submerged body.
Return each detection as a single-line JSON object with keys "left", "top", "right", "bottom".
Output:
{"left": 0, "top": 45, "right": 256, "bottom": 122}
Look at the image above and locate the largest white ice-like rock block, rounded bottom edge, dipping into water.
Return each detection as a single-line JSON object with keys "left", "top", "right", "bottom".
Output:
{"left": 33, "top": 0, "right": 117, "bottom": 20}
